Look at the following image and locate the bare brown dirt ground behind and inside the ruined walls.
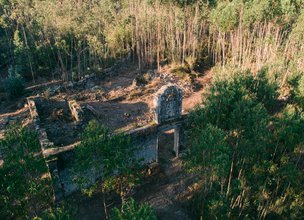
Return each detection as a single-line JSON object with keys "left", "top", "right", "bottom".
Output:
{"left": 10, "top": 68, "right": 211, "bottom": 147}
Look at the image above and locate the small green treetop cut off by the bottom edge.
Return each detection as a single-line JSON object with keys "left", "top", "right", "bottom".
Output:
{"left": 110, "top": 198, "right": 157, "bottom": 220}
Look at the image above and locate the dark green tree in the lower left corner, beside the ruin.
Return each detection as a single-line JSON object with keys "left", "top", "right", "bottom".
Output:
{"left": 0, "top": 125, "right": 53, "bottom": 219}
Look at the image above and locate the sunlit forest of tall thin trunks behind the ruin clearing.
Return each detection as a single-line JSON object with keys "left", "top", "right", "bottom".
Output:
{"left": 0, "top": 0, "right": 304, "bottom": 84}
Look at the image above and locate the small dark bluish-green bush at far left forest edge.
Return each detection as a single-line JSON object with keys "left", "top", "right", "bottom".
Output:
{"left": 4, "top": 67, "right": 24, "bottom": 98}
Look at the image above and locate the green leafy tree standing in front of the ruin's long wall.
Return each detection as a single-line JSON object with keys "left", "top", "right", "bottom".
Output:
{"left": 75, "top": 121, "right": 140, "bottom": 200}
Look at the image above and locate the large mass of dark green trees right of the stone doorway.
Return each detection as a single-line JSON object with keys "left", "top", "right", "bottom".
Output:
{"left": 187, "top": 70, "right": 304, "bottom": 219}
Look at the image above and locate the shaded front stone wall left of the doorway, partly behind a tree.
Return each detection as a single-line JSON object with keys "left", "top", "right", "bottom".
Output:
{"left": 45, "top": 125, "right": 158, "bottom": 198}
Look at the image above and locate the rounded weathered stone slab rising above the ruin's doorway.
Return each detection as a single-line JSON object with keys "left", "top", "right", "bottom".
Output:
{"left": 153, "top": 84, "right": 183, "bottom": 124}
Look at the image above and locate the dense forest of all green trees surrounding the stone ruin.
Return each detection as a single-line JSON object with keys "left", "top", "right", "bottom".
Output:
{"left": 0, "top": 0, "right": 304, "bottom": 219}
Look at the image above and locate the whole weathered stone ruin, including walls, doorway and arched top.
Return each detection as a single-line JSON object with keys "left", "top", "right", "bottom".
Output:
{"left": 28, "top": 84, "right": 185, "bottom": 201}
